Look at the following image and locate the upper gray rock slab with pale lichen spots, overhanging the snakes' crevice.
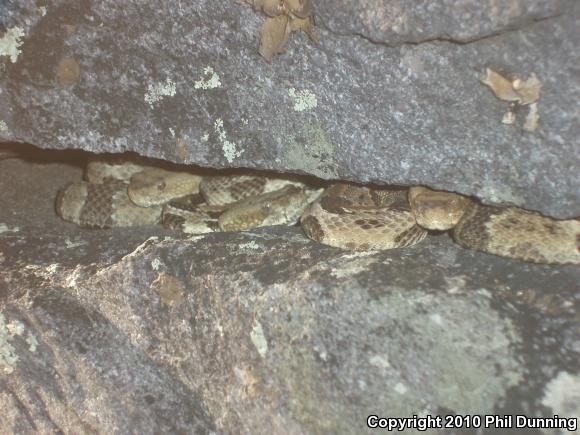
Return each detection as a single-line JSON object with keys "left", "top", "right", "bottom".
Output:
{"left": 0, "top": 0, "right": 580, "bottom": 217}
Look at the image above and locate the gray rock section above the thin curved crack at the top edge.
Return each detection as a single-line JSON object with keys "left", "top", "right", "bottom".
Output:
{"left": 316, "top": 0, "right": 572, "bottom": 46}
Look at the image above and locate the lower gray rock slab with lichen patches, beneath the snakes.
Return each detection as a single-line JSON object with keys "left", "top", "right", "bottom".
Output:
{"left": 0, "top": 153, "right": 580, "bottom": 434}
